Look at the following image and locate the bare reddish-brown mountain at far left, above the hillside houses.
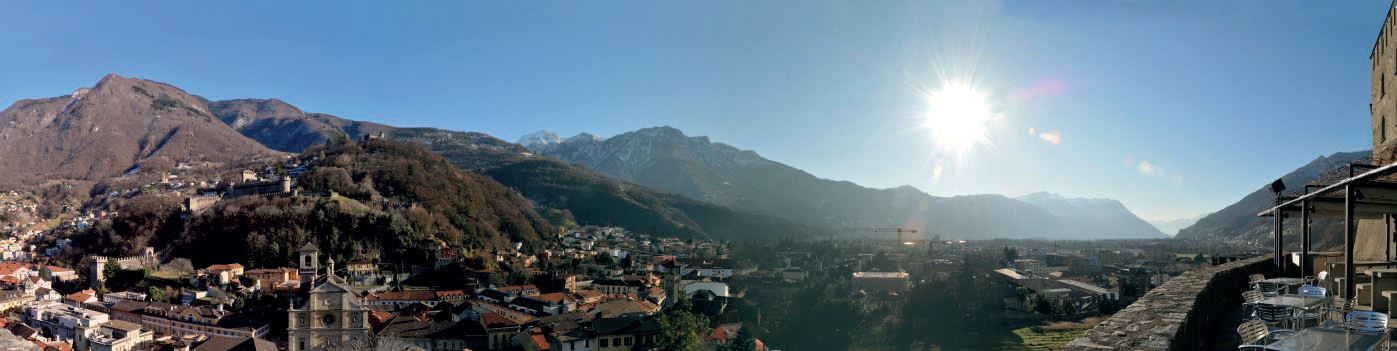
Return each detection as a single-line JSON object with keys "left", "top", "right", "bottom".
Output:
{"left": 0, "top": 74, "right": 279, "bottom": 186}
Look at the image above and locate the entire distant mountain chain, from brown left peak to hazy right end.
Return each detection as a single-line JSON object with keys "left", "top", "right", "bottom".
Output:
{"left": 0, "top": 74, "right": 1164, "bottom": 239}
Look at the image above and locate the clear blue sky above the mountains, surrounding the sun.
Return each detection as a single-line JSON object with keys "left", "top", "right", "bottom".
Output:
{"left": 0, "top": 0, "right": 1390, "bottom": 218}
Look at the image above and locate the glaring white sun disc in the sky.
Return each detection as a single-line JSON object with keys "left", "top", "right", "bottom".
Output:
{"left": 925, "top": 84, "right": 993, "bottom": 154}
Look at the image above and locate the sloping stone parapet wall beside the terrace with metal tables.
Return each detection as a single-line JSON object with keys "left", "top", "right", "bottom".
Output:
{"left": 1066, "top": 256, "right": 1294, "bottom": 351}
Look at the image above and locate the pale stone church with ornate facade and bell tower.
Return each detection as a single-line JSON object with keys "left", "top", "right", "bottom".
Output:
{"left": 286, "top": 243, "right": 372, "bottom": 351}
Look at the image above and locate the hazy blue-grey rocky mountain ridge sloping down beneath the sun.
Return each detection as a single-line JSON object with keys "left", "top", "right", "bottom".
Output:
{"left": 518, "top": 126, "right": 1164, "bottom": 239}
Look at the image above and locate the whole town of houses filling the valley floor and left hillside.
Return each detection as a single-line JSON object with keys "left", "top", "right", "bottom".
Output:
{"left": 0, "top": 137, "right": 1257, "bottom": 351}
